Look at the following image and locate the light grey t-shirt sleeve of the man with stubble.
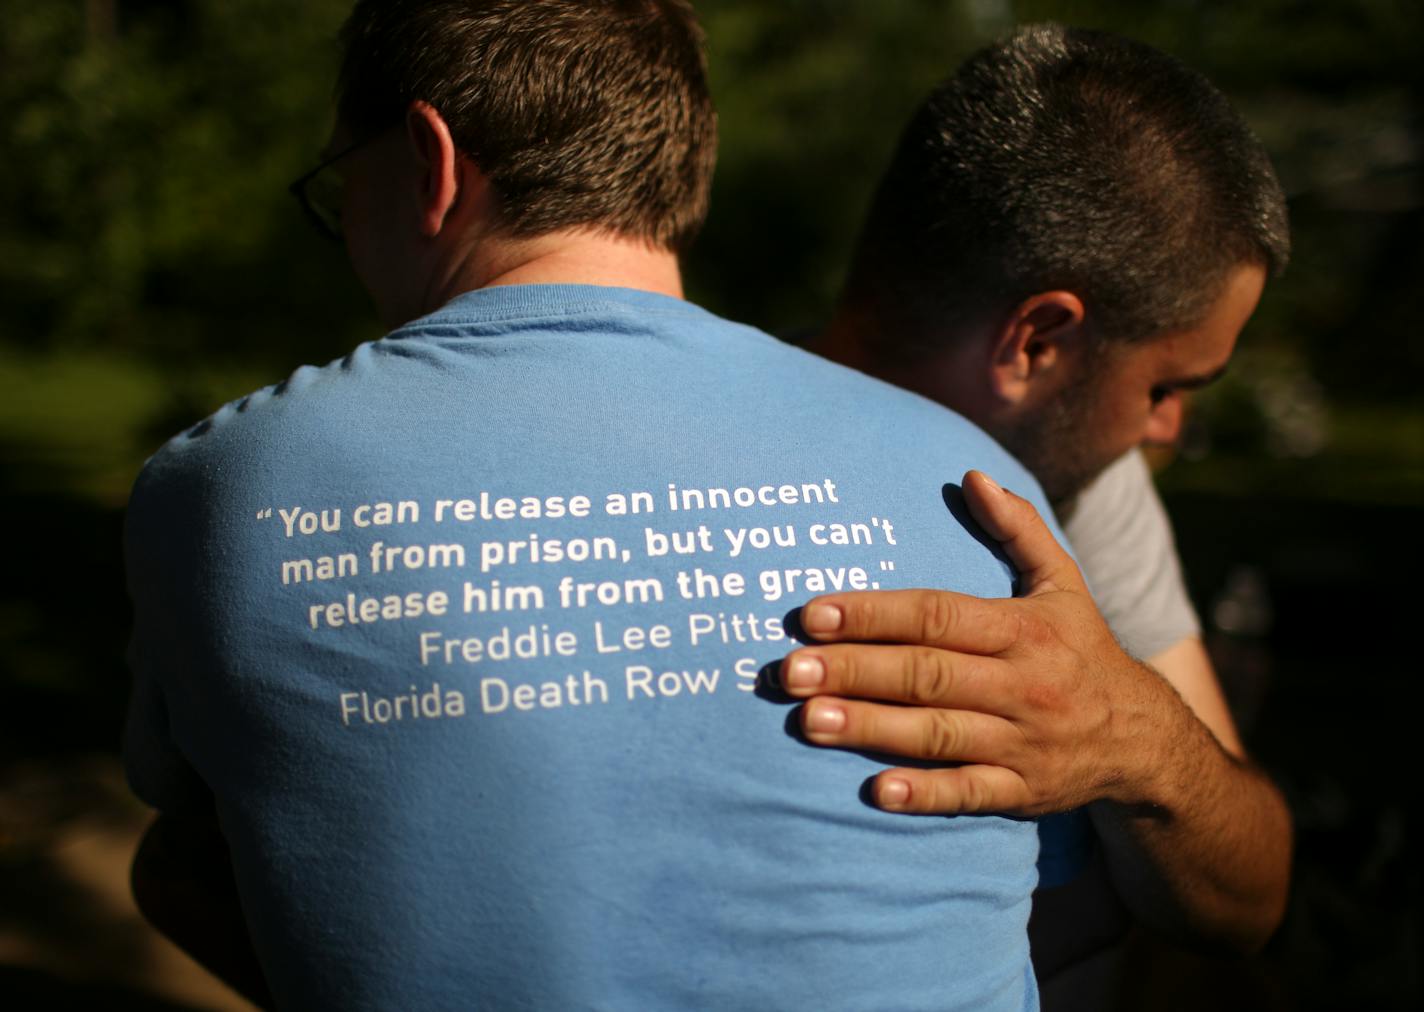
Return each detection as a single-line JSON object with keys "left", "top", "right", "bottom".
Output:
{"left": 1064, "top": 450, "right": 1202, "bottom": 659}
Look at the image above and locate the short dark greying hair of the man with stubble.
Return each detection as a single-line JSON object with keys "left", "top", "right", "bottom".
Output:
{"left": 844, "top": 24, "right": 1290, "bottom": 364}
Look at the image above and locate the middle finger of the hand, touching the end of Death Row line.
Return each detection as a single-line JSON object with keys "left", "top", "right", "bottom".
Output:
{"left": 780, "top": 643, "right": 1018, "bottom": 717}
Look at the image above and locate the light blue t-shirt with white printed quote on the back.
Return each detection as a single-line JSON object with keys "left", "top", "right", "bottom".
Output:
{"left": 125, "top": 286, "right": 1070, "bottom": 1011}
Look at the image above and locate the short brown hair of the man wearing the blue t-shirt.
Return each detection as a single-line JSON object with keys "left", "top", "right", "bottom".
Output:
{"left": 337, "top": 0, "right": 716, "bottom": 251}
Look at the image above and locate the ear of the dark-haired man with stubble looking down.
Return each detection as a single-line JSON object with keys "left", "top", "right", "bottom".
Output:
{"left": 990, "top": 290, "right": 1088, "bottom": 404}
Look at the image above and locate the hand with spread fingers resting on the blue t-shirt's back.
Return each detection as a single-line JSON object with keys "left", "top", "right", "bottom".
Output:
{"left": 780, "top": 471, "right": 1185, "bottom": 816}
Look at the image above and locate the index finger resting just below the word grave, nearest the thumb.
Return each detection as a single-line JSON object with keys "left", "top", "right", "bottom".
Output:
{"left": 800, "top": 591, "right": 1020, "bottom": 653}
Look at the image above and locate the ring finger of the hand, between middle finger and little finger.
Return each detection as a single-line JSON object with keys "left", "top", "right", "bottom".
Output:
{"left": 800, "top": 696, "right": 1024, "bottom": 763}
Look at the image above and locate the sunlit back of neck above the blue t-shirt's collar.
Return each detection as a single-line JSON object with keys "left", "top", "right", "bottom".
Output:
{"left": 423, "top": 231, "right": 682, "bottom": 312}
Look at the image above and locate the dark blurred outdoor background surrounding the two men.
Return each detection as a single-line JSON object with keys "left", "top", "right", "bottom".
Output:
{"left": 0, "top": 0, "right": 1424, "bottom": 1009}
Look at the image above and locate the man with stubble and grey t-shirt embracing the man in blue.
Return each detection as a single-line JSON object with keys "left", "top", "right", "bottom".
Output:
{"left": 782, "top": 24, "right": 1292, "bottom": 999}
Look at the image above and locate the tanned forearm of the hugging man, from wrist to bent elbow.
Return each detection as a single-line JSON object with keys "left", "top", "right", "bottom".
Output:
{"left": 1089, "top": 683, "right": 1292, "bottom": 952}
